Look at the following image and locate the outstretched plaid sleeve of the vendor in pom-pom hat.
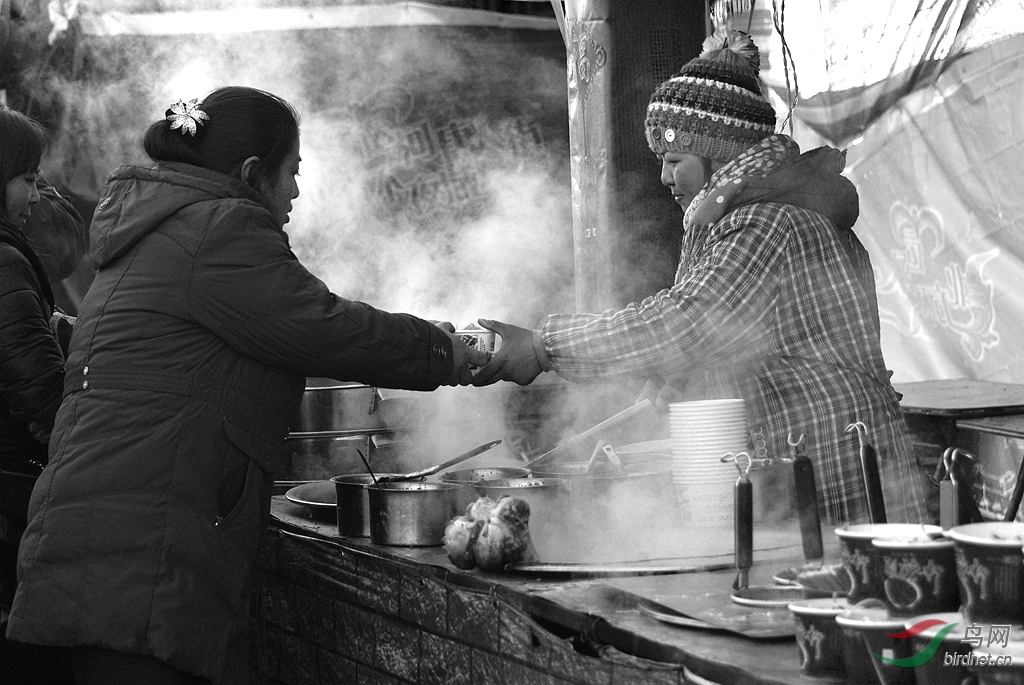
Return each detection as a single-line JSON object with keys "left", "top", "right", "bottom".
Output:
{"left": 542, "top": 205, "right": 788, "bottom": 381}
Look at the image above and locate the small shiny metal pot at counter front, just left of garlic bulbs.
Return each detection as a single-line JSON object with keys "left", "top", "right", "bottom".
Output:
{"left": 367, "top": 480, "right": 459, "bottom": 547}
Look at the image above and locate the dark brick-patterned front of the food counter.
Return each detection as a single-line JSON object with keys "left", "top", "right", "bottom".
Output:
{"left": 252, "top": 528, "right": 686, "bottom": 685}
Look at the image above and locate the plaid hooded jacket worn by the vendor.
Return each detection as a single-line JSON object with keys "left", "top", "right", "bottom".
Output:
{"left": 541, "top": 135, "right": 925, "bottom": 524}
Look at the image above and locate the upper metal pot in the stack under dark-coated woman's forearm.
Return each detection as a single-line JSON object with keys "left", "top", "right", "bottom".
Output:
{"left": 292, "top": 378, "right": 384, "bottom": 433}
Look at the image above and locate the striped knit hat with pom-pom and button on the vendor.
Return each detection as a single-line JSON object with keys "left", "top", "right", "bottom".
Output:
{"left": 645, "top": 31, "right": 775, "bottom": 162}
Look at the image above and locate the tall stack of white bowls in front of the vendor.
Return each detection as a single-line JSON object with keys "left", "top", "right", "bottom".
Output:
{"left": 669, "top": 399, "right": 748, "bottom": 555}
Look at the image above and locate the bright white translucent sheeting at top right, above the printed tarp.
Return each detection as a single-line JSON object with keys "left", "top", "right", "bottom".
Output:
{"left": 715, "top": 0, "right": 1024, "bottom": 145}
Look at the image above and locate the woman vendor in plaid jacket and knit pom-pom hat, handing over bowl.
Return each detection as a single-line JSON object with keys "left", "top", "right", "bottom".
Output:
{"left": 474, "top": 32, "right": 925, "bottom": 523}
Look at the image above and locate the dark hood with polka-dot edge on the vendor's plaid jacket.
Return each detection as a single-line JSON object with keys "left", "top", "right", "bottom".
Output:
{"left": 693, "top": 146, "right": 860, "bottom": 230}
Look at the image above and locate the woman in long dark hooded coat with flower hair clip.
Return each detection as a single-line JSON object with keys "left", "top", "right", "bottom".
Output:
{"left": 8, "top": 86, "right": 487, "bottom": 685}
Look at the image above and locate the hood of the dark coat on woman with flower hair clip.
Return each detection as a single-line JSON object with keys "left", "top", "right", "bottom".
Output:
{"left": 89, "top": 163, "right": 269, "bottom": 268}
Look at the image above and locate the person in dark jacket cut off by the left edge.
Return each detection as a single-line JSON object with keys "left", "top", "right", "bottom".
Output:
{"left": 0, "top": 105, "right": 77, "bottom": 684}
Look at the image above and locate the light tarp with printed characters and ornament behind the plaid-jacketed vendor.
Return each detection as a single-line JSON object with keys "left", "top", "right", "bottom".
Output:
{"left": 847, "top": 36, "right": 1024, "bottom": 382}
